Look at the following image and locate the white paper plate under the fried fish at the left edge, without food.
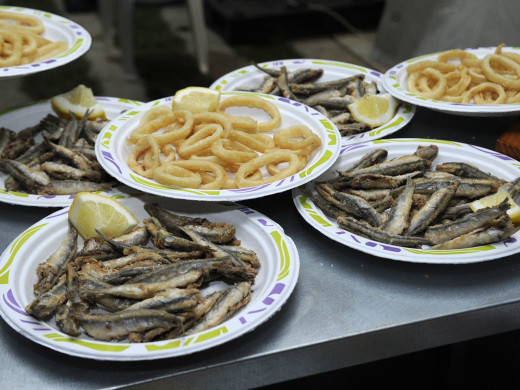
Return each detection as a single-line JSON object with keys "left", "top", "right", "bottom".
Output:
{"left": 0, "top": 96, "right": 144, "bottom": 207}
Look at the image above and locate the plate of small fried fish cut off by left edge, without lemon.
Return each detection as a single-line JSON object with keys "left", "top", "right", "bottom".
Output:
{"left": 0, "top": 96, "right": 143, "bottom": 207}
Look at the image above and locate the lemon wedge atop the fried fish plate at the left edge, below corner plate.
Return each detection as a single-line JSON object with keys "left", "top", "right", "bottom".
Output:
{"left": 51, "top": 84, "right": 106, "bottom": 120}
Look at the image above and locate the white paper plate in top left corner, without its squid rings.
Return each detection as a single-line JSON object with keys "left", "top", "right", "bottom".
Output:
{"left": 0, "top": 6, "right": 92, "bottom": 78}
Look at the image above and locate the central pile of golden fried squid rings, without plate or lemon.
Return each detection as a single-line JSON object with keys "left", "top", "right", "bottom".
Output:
{"left": 127, "top": 95, "right": 321, "bottom": 190}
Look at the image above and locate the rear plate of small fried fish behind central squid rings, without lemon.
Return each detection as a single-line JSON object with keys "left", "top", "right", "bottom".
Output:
{"left": 211, "top": 59, "right": 415, "bottom": 145}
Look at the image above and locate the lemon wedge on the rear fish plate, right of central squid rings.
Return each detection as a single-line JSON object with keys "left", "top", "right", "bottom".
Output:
{"left": 348, "top": 93, "right": 399, "bottom": 127}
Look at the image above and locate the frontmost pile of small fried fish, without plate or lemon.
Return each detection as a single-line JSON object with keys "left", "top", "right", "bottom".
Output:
{"left": 26, "top": 203, "right": 260, "bottom": 342}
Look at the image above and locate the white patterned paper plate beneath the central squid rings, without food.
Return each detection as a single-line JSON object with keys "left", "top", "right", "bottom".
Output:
{"left": 96, "top": 92, "right": 341, "bottom": 201}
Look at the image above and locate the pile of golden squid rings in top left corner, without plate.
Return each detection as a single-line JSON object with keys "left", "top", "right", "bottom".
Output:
{"left": 0, "top": 11, "right": 68, "bottom": 67}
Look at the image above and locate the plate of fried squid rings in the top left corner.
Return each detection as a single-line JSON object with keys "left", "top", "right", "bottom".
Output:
{"left": 0, "top": 6, "right": 92, "bottom": 78}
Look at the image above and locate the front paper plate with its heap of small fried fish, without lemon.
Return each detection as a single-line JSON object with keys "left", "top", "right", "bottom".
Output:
{"left": 0, "top": 192, "right": 299, "bottom": 361}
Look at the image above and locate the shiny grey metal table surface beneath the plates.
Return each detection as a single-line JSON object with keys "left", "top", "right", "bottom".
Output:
{"left": 0, "top": 108, "right": 520, "bottom": 389}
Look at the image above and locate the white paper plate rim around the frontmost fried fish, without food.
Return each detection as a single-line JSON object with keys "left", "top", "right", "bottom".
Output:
{"left": 0, "top": 190, "right": 299, "bottom": 361}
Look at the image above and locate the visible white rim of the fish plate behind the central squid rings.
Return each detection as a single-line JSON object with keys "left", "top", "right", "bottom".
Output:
{"left": 210, "top": 58, "right": 416, "bottom": 145}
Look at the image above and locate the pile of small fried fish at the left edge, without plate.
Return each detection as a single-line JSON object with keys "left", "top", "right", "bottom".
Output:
{"left": 0, "top": 111, "right": 114, "bottom": 195}
